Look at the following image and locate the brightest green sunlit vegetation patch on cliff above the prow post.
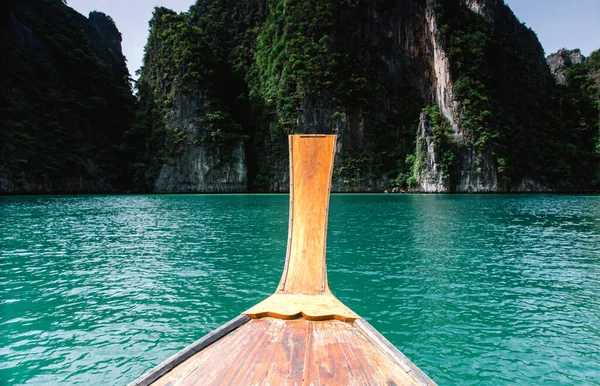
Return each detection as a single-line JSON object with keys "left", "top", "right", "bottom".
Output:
{"left": 247, "top": 0, "right": 334, "bottom": 131}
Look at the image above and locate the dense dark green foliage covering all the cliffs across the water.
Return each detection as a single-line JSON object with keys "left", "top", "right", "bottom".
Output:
{"left": 0, "top": 0, "right": 600, "bottom": 191}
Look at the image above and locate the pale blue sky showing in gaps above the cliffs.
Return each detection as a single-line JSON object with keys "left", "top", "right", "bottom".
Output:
{"left": 67, "top": 0, "right": 600, "bottom": 78}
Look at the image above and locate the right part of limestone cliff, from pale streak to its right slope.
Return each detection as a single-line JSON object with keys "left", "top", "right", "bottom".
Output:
{"left": 416, "top": 0, "right": 598, "bottom": 192}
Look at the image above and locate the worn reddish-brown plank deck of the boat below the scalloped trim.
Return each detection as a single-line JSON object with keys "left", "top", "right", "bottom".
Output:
{"left": 154, "top": 318, "right": 434, "bottom": 386}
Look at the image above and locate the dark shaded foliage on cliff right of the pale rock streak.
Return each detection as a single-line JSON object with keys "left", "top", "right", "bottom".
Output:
{"left": 439, "top": 1, "right": 598, "bottom": 190}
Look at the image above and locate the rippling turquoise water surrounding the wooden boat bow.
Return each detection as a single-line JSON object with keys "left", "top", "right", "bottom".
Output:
{"left": 0, "top": 195, "right": 600, "bottom": 385}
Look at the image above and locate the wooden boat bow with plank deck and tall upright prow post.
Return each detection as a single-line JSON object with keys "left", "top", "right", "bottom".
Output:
{"left": 130, "top": 135, "right": 435, "bottom": 386}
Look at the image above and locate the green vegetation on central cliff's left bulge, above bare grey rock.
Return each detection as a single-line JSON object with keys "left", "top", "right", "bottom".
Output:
{"left": 126, "top": 1, "right": 254, "bottom": 191}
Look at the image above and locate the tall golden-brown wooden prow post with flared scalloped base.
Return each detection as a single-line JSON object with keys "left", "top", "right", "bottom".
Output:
{"left": 245, "top": 135, "right": 358, "bottom": 321}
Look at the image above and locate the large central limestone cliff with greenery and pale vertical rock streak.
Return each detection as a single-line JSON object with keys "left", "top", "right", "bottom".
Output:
{"left": 136, "top": 0, "right": 597, "bottom": 192}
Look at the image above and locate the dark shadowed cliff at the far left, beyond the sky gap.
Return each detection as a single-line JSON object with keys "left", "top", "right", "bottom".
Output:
{"left": 0, "top": 0, "right": 134, "bottom": 193}
